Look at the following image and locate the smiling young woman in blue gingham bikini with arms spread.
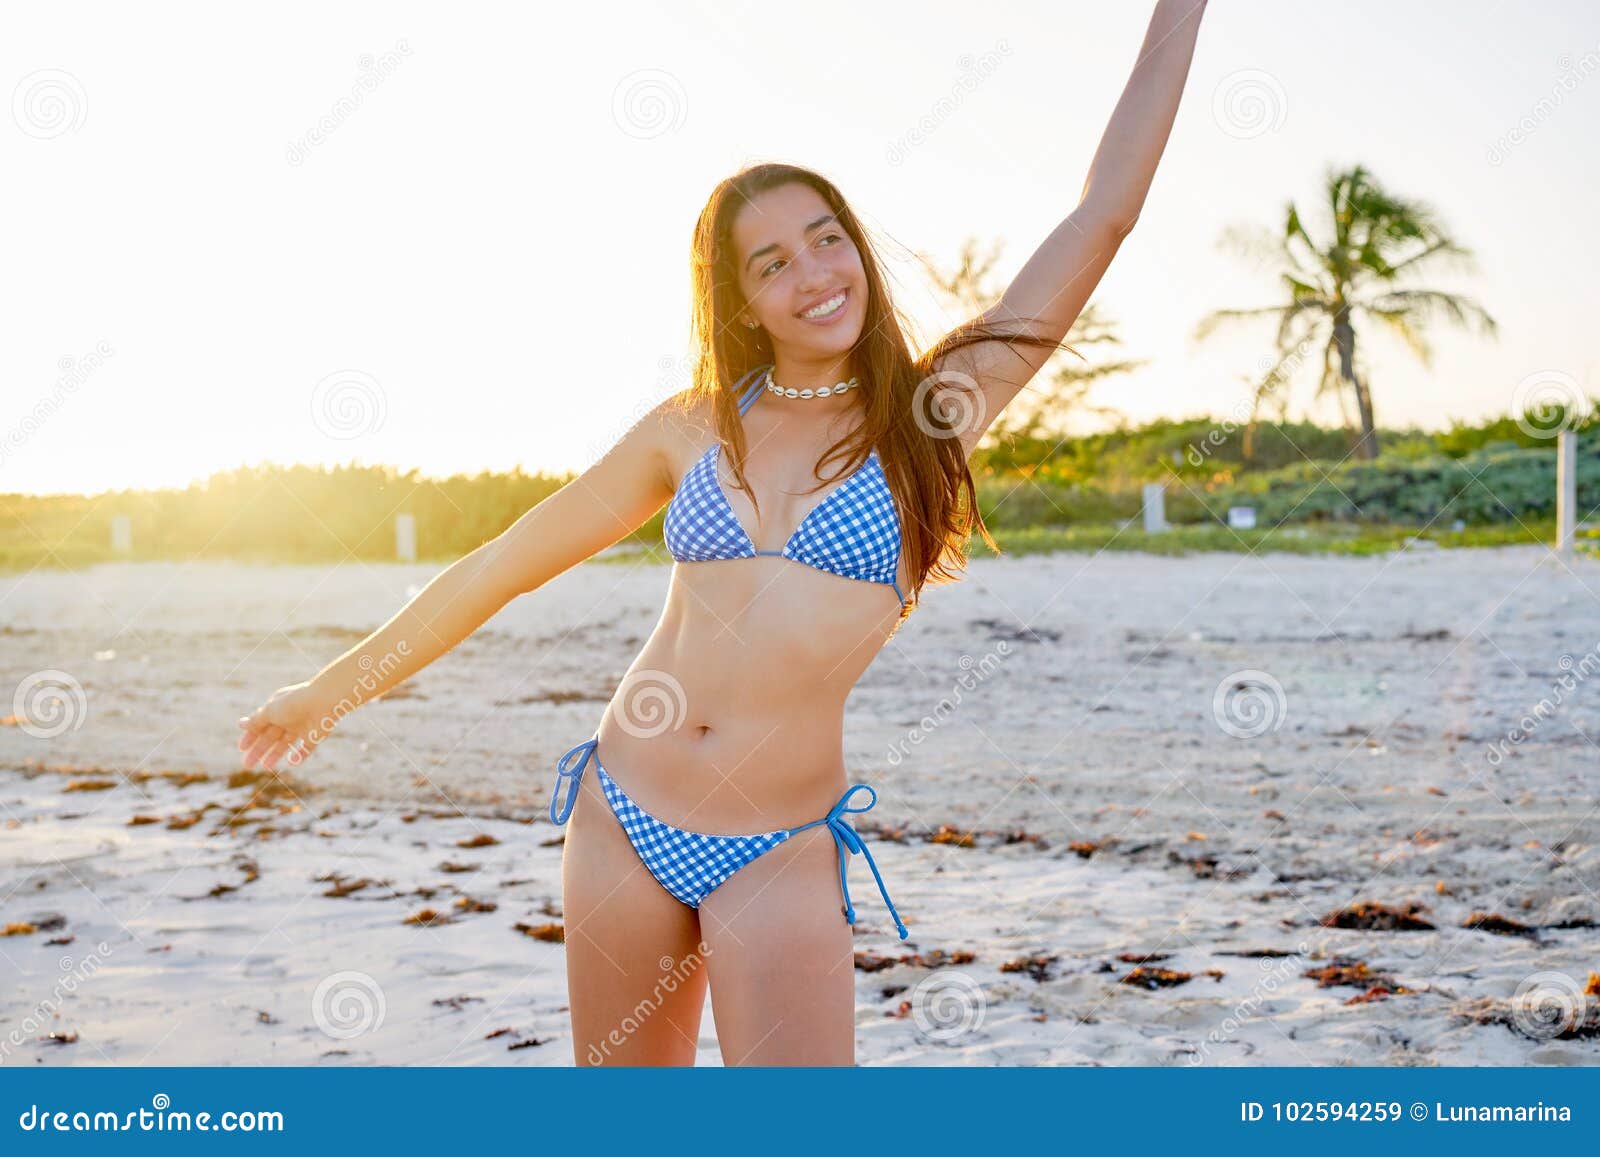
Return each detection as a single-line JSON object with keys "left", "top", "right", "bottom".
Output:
{"left": 238, "top": 0, "right": 1205, "bottom": 1064}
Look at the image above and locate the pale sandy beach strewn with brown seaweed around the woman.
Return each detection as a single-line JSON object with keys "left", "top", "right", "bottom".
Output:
{"left": 0, "top": 547, "right": 1600, "bottom": 1066}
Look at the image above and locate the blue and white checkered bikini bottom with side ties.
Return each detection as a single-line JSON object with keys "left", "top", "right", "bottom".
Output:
{"left": 550, "top": 736, "right": 910, "bottom": 939}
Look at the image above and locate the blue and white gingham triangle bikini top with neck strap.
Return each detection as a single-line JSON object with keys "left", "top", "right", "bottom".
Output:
{"left": 662, "top": 365, "right": 906, "bottom": 607}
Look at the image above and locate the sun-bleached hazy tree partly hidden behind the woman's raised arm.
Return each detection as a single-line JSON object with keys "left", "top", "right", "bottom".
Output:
{"left": 922, "top": 237, "right": 1142, "bottom": 443}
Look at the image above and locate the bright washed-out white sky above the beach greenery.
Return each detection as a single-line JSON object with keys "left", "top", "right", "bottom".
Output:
{"left": 0, "top": 0, "right": 1600, "bottom": 493}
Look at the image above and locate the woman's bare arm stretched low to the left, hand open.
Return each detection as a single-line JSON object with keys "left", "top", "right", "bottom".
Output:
{"left": 238, "top": 402, "right": 683, "bottom": 768}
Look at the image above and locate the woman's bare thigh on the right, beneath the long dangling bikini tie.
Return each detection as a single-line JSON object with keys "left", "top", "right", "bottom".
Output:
{"left": 699, "top": 826, "right": 861, "bottom": 1066}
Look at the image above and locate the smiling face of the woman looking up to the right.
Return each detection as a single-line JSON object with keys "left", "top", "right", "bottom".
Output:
{"left": 733, "top": 184, "right": 867, "bottom": 357}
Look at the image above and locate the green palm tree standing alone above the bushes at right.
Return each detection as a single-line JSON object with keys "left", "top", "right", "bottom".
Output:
{"left": 1195, "top": 165, "right": 1496, "bottom": 459}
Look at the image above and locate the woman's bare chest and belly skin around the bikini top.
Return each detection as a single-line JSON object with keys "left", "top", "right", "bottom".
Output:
{"left": 598, "top": 405, "right": 909, "bottom": 834}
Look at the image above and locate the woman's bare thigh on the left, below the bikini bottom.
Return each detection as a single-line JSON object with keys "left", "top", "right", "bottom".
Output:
{"left": 562, "top": 752, "right": 707, "bottom": 1064}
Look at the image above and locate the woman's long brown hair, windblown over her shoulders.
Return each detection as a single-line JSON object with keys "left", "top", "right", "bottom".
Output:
{"left": 683, "top": 163, "right": 1070, "bottom": 619}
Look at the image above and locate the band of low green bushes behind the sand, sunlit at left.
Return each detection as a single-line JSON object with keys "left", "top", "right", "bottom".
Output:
{"left": 0, "top": 413, "right": 1600, "bottom": 571}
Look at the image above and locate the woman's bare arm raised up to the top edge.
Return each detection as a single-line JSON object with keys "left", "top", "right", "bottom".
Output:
{"left": 949, "top": 0, "right": 1205, "bottom": 450}
